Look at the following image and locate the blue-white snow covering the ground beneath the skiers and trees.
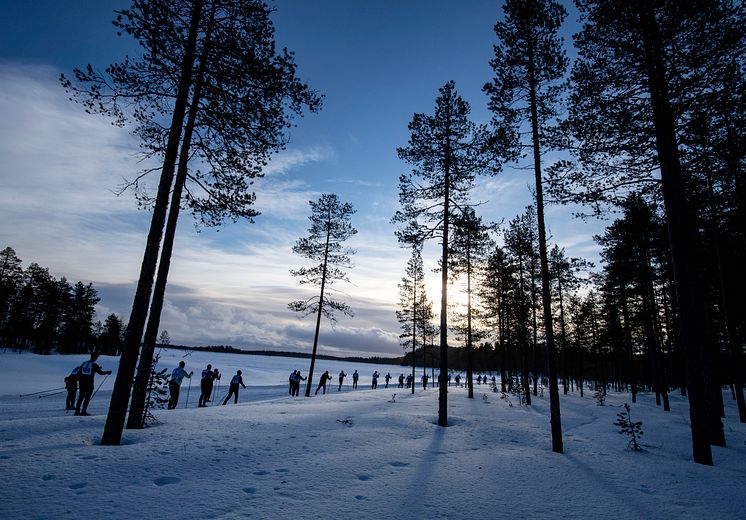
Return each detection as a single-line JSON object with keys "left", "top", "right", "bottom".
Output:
{"left": 0, "top": 350, "right": 746, "bottom": 520}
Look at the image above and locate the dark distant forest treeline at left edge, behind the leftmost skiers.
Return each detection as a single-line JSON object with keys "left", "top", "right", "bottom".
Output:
{"left": 0, "top": 247, "right": 124, "bottom": 356}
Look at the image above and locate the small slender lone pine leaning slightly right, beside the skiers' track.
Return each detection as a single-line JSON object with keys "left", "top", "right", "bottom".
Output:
{"left": 288, "top": 193, "right": 357, "bottom": 397}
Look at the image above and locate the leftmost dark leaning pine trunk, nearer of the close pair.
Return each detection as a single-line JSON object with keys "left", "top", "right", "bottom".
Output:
{"left": 101, "top": 0, "right": 202, "bottom": 446}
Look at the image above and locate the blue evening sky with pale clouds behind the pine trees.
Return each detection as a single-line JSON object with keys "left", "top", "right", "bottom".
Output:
{"left": 0, "top": 0, "right": 602, "bottom": 356}
